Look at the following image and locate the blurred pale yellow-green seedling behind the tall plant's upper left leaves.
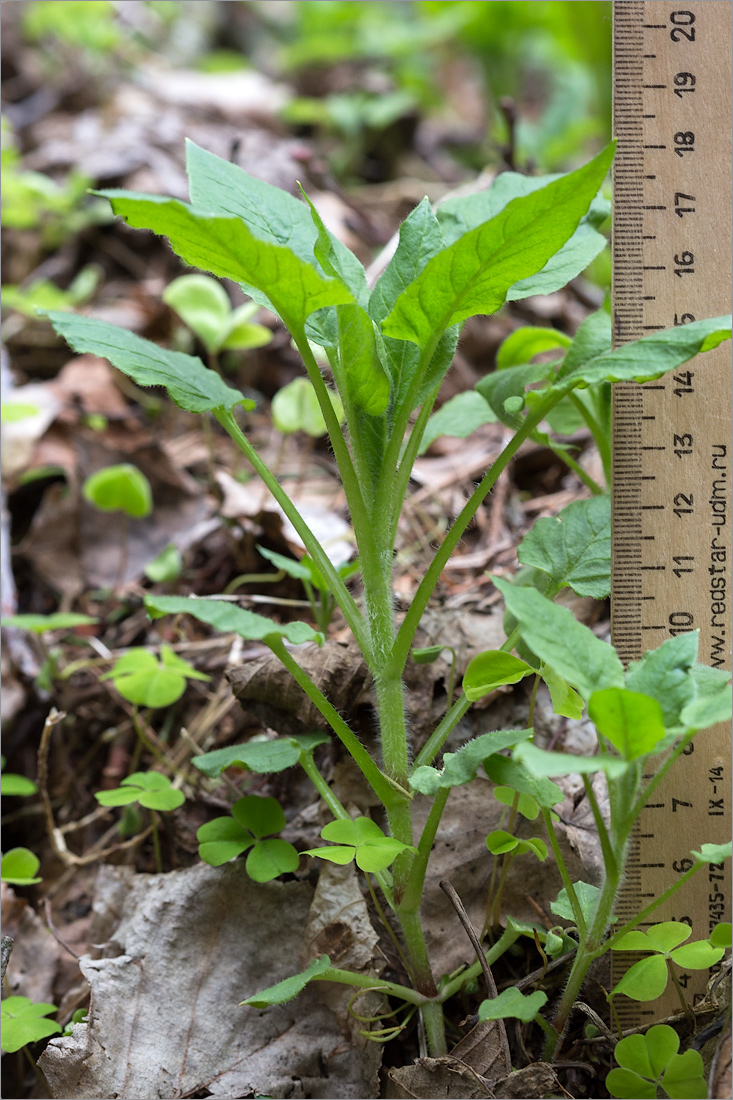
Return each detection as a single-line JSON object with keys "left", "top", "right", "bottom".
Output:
{"left": 163, "top": 275, "right": 272, "bottom": 356}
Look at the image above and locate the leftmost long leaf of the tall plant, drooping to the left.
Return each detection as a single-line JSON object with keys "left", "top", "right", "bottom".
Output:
{"left": 46, "top": 312, "right": 248, "bottom": 413}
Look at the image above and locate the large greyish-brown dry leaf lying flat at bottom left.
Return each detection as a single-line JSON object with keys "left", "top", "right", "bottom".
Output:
{"left": 41, "top": 862, "right": 383, "bottom": 1100}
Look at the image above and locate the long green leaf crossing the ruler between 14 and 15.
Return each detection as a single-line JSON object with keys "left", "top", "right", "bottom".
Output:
{"left": 557, "top": 314, "right": 731, "bottom": 387}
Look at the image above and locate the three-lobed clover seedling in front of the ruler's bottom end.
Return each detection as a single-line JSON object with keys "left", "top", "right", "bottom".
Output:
{"left": 609, "top": 919, "right": 725, "bottom": 1003}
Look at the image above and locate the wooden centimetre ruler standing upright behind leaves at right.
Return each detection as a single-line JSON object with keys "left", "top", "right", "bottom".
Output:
{"left": 611, "top": 0, "right": 733, "bottom": 1027}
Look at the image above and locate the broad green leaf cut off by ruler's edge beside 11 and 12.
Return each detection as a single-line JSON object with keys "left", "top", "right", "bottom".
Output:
{"left": 517, "top": 496, "right": 611, "bottom": 600}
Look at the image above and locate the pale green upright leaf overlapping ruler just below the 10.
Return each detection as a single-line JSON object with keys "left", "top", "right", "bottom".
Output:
{"left": 626, "top": 630, "right": 699, "bottom": 729}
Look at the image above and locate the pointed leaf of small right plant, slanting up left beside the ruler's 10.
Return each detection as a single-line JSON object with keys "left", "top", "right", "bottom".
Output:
{"left": 494, "top": 578, "right": 624, "bottom": 704}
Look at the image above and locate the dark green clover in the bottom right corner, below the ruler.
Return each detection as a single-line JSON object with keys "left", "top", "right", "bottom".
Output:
{"left": 605, "top": 1024, "right": 708, "bottom": 1100}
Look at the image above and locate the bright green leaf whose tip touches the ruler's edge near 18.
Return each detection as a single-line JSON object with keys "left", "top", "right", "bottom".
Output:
{"left": 383, "top": 145, "right": 613, "bottom": 347}
